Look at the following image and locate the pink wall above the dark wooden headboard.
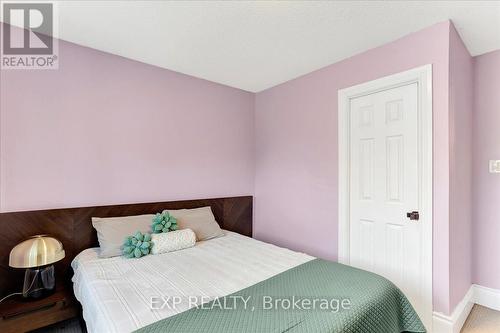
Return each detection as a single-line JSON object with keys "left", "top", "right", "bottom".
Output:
{"left": 0, "top": 28, "right": 254, "bottom": 211}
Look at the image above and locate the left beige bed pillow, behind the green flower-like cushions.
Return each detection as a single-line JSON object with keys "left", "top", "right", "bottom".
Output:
{"left": 92, "top": 214, "right": 154, "bottom": 258}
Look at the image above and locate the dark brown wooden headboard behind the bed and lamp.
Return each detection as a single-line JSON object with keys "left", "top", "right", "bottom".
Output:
{"left": 0, "top": 196, "right": 253, "bottom": 295}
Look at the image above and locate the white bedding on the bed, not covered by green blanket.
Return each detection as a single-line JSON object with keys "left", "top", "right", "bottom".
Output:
{"left": 72, "top": 231, "right": 314, "bottom": 333}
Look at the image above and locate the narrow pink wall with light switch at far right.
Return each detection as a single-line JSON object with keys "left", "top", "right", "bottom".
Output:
{"left": 473, "top": 50, "right": 500, "bottom": 289}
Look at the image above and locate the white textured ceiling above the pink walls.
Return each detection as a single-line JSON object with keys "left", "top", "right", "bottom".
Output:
{"left": 7, "top": 0, "right": 500, "bottom": 92}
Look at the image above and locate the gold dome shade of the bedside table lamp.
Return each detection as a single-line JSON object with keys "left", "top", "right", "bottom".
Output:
{"left": 9, "top": 235, "right": 65, "bottom": 268}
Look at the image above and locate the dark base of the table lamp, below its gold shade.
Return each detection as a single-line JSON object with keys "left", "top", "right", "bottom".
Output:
{"left": 23, "top": 265, "right": 56, "bottom": 298}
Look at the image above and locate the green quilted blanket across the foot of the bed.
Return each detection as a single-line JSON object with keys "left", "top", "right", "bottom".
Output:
{"left": 137, "top": 259, "right": 425, "bottom": 333}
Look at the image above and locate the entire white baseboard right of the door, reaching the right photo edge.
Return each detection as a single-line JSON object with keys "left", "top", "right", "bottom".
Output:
{"left": 432, "top": 284, "right": 500, "bottom": 333}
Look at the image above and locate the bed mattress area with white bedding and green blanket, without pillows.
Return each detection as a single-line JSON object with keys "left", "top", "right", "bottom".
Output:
{"left": 72, "top": 231, "right": 425, "bottom": 333}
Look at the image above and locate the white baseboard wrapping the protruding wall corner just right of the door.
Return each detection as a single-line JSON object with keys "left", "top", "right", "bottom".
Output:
{"left": 432, "top": 286, "right": 474, "bottom": 333}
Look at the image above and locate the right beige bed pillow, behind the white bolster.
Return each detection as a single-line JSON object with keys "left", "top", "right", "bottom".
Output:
{"left": 166, "top": 206, "right": 224, "bottom": 241}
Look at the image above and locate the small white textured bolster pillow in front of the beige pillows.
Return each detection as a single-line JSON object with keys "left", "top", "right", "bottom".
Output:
{"left": 151, "top": 229, "right": 196, "bottom": 254}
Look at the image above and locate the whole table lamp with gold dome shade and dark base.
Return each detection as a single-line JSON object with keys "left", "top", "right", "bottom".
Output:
{"left": 9, "top": 235, "right": 65, "bottom": 298}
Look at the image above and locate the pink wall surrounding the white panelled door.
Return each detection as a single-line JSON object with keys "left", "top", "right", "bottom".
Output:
{"left": 254, "top": 22, "right": 456, "bottom": 313}
